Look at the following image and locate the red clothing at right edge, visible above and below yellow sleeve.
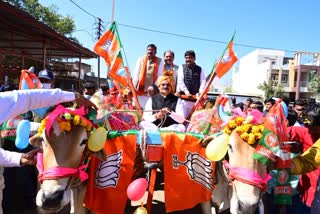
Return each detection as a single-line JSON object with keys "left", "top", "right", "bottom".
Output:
{"left": 287, "top": 126, "right": 320, "bottom": 206}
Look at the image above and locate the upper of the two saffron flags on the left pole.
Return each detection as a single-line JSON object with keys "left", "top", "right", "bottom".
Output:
{"left": 94, "top": 22, "right": 121, "bottom": 67}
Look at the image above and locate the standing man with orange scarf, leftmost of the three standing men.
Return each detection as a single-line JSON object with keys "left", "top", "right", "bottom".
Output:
{"left": 133, "top": 44, "right": 163, "bottom": 108}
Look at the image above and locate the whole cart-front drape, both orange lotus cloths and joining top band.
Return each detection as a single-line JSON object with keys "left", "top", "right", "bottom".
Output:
{"left": 85, "top": 130, "right": 215, "bottom": 213}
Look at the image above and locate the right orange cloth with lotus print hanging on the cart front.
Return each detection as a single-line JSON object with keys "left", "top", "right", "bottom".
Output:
{"left": 160, "top": 132, "right": 215, "bottom": 212}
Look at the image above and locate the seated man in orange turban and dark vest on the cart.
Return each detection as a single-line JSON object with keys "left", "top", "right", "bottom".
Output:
{"left": 139, "top": 76, "right": 185, "bottom": 132}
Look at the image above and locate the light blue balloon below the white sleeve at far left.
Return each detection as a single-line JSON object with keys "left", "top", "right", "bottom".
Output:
{"left": 15, "top": 120, "right": 30, "bottom": 149}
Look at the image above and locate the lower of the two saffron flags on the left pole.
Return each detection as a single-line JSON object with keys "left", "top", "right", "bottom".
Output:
{"left": 108, "top": 52, "right": 128, "bottom": 87}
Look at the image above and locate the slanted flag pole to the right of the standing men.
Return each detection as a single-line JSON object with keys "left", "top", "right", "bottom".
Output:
{"left": 186, "top": 32, "right": 236, "bottom": 120}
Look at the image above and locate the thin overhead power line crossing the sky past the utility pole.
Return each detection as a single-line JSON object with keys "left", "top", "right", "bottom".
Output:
{"left": 69, "top": 0, "right": 297, "bottom": 53}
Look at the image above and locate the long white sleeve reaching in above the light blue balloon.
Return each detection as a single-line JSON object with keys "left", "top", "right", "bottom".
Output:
{"left": 0, "top": 89, "right": 75, "bottom": 124}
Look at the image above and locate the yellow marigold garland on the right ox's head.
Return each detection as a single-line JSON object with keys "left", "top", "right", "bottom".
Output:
{"left": 223, "top": 117, "right": 264, "bottom": 145}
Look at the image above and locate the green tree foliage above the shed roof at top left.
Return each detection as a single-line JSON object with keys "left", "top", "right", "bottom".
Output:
{"left": 8, "top": 0, "right": 75, "bottom": 35}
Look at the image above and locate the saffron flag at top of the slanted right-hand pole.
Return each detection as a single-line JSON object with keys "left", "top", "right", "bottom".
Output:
{"left": 216, "top": 34, "right": 238, "bottom": 78}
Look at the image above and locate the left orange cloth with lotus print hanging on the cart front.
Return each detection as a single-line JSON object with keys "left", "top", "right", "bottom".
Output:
{"left": 84, "top": 132, "right": 137, "bottom": 214}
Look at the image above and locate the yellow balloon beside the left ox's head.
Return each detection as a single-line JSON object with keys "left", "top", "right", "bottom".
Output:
{"left": 88, "top": 127, "right": 107, "bottom": 152}
